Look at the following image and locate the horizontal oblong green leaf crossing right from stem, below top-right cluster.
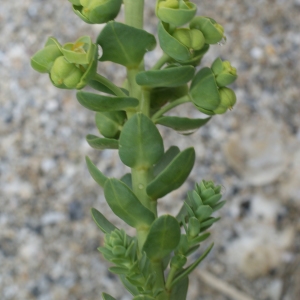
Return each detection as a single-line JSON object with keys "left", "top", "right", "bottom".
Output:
{"left": 136, "top": 66, "right": 195, "bottom": 87}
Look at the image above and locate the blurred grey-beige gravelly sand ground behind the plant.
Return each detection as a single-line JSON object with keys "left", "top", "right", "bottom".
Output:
{"left": 0, "top": 0, "right": 300, "bottom": 300}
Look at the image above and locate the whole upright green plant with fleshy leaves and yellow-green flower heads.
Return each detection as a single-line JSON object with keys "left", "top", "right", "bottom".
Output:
{"left": 31, "top": 0, "right": 237, "bottom": 300}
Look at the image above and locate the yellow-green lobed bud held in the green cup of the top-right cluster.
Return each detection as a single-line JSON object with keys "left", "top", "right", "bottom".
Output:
{"left": 173, "top": 28, "right": 205, "bottom": 50}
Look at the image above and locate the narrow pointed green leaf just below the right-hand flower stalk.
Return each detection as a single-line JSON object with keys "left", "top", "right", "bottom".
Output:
{"left": 155, "top": 117, "right": 211, "bottom": 135}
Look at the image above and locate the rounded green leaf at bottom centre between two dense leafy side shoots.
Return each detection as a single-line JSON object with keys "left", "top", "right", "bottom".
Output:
{"left": 143, "top": 215, "right": 180, "bottom": 261}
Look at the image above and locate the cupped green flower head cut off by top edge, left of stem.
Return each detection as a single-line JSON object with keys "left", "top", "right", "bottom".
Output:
{"left": 69, "top": 0, "right": 122, "bottom": 24}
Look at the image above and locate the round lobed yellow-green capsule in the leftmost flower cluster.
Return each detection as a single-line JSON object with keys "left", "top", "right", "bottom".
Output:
{"left": 50, "top": 56, "right": 84, "bottom": 89}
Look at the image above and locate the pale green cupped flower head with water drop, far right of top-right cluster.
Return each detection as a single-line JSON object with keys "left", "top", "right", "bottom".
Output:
{"left": 190, "top": 17, "right": 225, "bottom": 44}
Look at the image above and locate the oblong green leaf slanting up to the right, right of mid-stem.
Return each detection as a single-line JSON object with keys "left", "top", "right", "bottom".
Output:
{"left": 146, "top": 148, "right": 195, "bottom": 199}
